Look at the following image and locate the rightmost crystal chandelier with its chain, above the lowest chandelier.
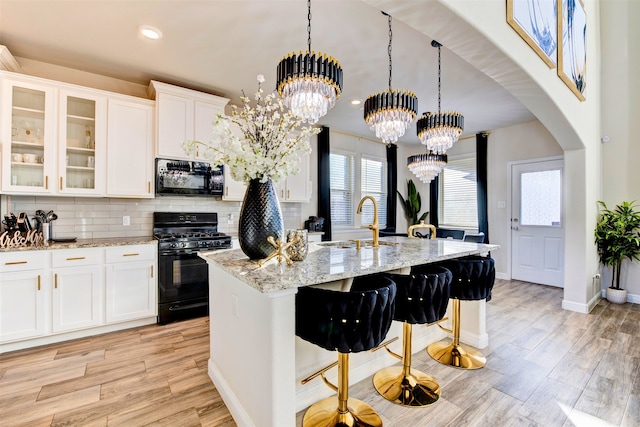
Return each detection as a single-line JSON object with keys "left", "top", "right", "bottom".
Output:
{"left": 417, "top": 40, "right": 464, "bottom": 154}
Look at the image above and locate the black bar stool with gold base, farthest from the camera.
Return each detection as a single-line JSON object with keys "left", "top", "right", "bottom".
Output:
{"left": 412, "top": 255, "right": 496, "bottom": 369}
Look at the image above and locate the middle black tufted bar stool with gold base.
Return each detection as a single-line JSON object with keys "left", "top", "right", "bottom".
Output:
{"left": 373, "top": 266, "right": 452, "bottom": 406}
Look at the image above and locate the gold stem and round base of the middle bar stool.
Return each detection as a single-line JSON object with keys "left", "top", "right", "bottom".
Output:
{"left": 373, "top": 322, "right": 440, "bottom": 406}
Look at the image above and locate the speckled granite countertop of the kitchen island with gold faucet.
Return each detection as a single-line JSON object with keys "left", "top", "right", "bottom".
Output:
{"left": 198, "top": 236, "right": 499, "bottom": 293}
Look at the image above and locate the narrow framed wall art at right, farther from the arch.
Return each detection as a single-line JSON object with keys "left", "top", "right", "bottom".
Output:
{"left": 557, "top": 0, "right": 587, "bottom": 101}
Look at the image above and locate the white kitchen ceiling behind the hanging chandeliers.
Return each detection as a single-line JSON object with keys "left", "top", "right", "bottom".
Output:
{"left": 0, "top": 0, "right": 535, "bottom": 144}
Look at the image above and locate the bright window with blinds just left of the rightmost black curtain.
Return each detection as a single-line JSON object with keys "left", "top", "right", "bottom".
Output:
{"left": 438, "top": 157, "right": 478, "bottom": 229}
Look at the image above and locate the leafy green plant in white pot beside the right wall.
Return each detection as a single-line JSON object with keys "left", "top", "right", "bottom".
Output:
{"left": 595, "top": 201, "right": 640, "bottom": 304}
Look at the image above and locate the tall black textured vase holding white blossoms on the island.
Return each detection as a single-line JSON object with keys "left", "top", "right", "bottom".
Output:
{"left": 238, "top": 179, "right": 284, "bottom": 259}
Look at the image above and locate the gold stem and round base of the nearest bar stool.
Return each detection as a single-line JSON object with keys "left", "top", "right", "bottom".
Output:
{"left": 302, "top": 353, "right": 382, "bottom": 427}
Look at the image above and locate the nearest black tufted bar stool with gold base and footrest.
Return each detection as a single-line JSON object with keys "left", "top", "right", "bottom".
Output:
{"left": 296, "top": 275, "right": 396, "bottom": 427}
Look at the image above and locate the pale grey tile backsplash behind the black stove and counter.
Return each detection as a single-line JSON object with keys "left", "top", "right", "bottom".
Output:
{"left": 2, "top": 196, "right": 306, "bottom": 239}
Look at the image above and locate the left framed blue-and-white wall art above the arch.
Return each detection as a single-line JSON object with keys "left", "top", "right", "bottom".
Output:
{"left": 507, "top": 0, "right": 563, "bottom": 68}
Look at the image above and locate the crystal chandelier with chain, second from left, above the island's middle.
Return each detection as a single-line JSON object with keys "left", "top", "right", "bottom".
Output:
{"left": 364, "top": 12, "right": 418, "bottom": 144}
